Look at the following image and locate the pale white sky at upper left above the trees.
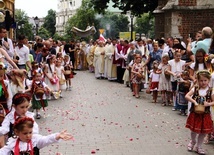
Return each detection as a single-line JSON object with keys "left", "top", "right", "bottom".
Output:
{"left": 15, "top": 0, "right": 57, "bottom": 18}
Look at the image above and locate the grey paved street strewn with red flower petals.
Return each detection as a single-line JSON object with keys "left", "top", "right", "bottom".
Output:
{"left": 37, "top": 71, "right": 214, "bottom": 155}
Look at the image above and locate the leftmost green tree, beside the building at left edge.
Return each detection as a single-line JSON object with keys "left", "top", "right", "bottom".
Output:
{"left": 15, "top": 9, "right": 33, "bottom": 40}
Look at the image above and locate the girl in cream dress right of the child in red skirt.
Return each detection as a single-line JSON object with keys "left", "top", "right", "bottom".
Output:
{"left": 157, "top": 54, "right": 172, "bottom": 106}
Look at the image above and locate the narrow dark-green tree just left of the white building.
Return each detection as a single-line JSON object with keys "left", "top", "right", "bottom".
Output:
{"left": 43, "top": 9, "right": 56, "bottom": 36}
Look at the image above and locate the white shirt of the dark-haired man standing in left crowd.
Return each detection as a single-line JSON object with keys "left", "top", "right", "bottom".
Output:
{"left": 15, "top": 45, "right": 30, "bottom": 65}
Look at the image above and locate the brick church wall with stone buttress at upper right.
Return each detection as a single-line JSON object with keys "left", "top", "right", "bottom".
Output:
{"left": 153, "top": 0, "right": 214, "bottom": 41}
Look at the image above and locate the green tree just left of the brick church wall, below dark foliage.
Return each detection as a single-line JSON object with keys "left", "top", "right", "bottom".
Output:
{"left": 134, "top": 13, "right": 154, "bottom": 38}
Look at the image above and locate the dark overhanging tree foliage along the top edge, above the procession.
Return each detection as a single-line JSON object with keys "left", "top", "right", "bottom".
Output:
{"left": 91, "top": 0, "right": 158, "bottom": 16}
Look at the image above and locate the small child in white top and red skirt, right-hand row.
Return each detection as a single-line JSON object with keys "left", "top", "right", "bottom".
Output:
{"left": 149, "top": 61, "right": 160, "bottom": 103}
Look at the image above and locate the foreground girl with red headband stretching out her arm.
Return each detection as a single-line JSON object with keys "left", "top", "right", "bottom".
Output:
{"left": 0, "top": 117, "right": 72, "bottom": 155}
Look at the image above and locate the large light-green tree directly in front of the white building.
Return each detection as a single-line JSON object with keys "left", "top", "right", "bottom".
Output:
{"left": 65, "top": 0, "right": 98, "bottom": 39}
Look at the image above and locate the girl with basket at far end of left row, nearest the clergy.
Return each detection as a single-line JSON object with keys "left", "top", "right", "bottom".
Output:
{"left": 64, "top": 55, "right": 73, "bottom": 91}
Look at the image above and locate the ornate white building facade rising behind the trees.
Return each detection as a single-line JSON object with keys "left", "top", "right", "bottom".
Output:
{"left": 56, "top": 0, "right": 82, "bottom": 35}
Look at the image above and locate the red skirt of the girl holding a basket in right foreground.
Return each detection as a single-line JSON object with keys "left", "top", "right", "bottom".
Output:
{"left": 186, "top": 112, "right": 213, "bottom": 134}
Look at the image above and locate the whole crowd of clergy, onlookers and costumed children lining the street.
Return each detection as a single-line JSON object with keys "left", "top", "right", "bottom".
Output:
{"left": 0, "top": 23, "right": 214, "bottom": 154}
